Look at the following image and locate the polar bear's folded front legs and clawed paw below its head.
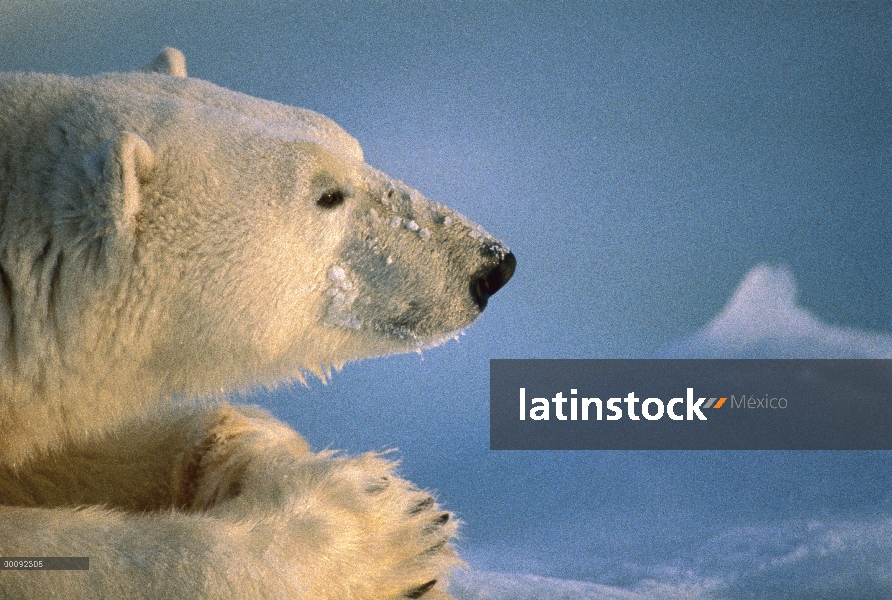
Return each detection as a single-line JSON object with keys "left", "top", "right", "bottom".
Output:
{"left": 0, "top": 406, "right": 459, "bottom": 600}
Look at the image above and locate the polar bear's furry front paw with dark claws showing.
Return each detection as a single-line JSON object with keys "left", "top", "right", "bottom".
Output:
{"left": 286, "top": 454, "right": 459, "bottom": 599}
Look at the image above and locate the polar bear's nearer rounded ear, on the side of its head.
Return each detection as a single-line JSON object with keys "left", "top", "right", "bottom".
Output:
{"left": 84, "top": 131, "right": 155, "bottom": 240}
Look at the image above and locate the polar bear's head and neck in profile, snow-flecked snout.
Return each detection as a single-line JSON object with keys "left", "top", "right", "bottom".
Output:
{"left": 0, "top": 50, "right": 515, "bottom": 393}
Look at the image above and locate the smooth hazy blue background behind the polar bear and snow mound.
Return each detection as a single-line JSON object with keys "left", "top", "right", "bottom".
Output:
{"left": 0, "top": 1, "right": 892, "bottom": 598}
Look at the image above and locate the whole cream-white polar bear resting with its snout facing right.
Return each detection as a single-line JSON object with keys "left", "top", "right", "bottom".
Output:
{"left": 0, "top": 49, "right": 516, "bottom": 600}
